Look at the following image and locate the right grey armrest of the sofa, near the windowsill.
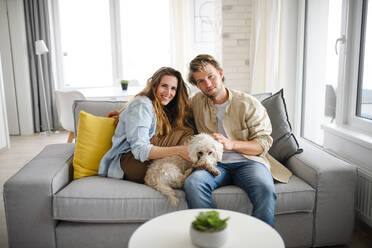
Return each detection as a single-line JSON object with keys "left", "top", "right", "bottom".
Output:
{"left": 288, "top": 139, "right": 356, "bottom": 246}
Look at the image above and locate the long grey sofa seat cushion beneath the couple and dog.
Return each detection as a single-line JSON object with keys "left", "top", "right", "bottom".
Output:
{"left": 53, "top": 176, "right": 315, "bottom": 223}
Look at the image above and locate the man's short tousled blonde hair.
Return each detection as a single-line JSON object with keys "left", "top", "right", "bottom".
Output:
{"left": 188, "top": 54, "right": 225, "bottom": 86}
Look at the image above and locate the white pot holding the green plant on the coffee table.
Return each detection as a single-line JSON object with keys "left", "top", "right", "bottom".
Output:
{"left": 190, "top": 225, "right": 228, "bottom": 248}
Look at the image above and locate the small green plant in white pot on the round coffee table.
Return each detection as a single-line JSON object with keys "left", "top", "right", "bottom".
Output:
{"left": 190, "top": 210, "right": 229, "bottom": 248}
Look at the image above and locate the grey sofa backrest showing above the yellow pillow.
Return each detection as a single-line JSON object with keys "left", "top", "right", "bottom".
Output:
{"left": 72, "top": 100, "right": 126, "bottom": 137}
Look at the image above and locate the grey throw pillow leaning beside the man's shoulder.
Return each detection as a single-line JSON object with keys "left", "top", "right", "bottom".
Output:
{"left": 261, "top": 89, "right": 303, "bottom": 163}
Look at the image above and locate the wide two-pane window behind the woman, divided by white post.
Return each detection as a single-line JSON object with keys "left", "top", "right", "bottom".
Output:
{"left": 54, "top": 0, "right": 172, "bottom": 88}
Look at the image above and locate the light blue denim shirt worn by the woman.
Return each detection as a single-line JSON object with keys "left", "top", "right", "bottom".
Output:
{"left": 98, "top": 96, "right": 156, "bottom": 179}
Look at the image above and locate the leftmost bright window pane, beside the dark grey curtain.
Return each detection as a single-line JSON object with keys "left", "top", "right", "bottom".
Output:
{"left": 59, "top": 0, "right": 113, "bottom": 87}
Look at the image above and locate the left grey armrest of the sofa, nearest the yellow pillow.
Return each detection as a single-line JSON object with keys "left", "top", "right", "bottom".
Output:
{"left": 3, "top": 144, "right": 74, "bottom": 248}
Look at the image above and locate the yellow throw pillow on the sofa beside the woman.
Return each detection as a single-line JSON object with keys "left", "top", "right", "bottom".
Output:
{"left": 73, "top": 111, "right": 116, "bottom": 179}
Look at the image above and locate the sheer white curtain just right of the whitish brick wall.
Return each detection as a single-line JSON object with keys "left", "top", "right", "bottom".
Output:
{"left": 249, "top": 0, "right": 283, "bottom": 94}
